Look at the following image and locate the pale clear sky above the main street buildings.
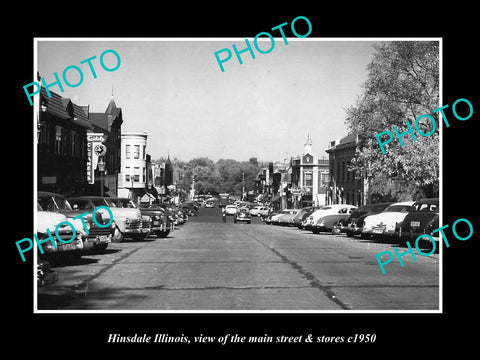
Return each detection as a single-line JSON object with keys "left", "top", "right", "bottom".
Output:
{"left": 36, "top": 37, "right": 382, "bottom": 161}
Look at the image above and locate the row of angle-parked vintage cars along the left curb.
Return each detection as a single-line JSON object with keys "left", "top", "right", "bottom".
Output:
{"left": 36, "top": 191, "right": 192, "bottom": 283}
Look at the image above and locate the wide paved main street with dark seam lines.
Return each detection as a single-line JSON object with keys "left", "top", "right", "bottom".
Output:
{"left": 38, "top": 208, "right": 439, "bottom": 311}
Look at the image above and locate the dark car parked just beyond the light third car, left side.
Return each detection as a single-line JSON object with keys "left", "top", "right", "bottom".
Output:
{"left": 108, "top": 197, "right": 174, "bottom": 238}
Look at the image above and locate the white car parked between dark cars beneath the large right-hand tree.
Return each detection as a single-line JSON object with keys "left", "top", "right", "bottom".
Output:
{"left": 361, "top": 201, "right": 413, "bottom": 239}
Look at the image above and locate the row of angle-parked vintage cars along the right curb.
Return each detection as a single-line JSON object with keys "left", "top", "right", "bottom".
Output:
{"left": 264, "top": 198, "right": 439, "bottom": 245}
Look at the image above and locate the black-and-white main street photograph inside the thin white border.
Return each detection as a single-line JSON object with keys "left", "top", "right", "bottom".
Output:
{"left": 31, "top": 37, "right": 442, "bottom": 312}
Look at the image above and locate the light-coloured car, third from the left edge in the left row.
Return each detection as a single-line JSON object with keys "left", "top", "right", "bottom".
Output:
{"left": 68, "top": 196, "right": 150, "bottom": 242}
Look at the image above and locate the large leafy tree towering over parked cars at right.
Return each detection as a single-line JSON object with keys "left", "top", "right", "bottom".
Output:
{"left": 346, "top": 41, "right": 439, "bottom": 200}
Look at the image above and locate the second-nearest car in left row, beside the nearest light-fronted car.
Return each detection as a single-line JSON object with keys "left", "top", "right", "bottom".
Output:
{"left": 37, "top": 191, "right": 115, "bottom": 251}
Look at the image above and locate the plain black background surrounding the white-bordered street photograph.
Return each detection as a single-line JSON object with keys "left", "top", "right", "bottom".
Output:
{"left": 2, "top": 2, "right": 480, "bottom": 357}
